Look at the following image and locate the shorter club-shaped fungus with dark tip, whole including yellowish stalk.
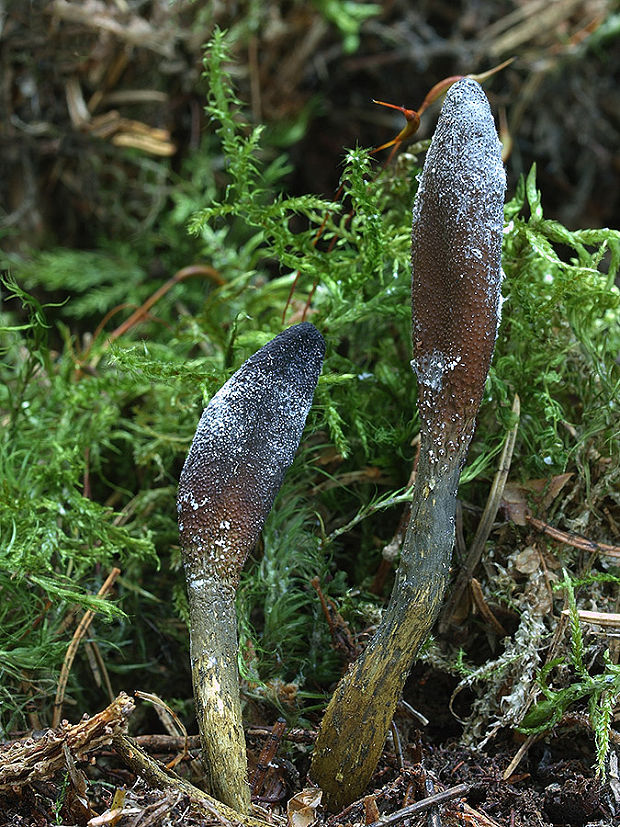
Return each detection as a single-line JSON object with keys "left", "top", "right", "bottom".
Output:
{"left": 178, "top": 322, "right": 325, "bottom": 813}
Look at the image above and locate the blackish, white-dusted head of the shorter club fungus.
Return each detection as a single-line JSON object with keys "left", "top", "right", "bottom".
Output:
{"left": 177, "top": 322, "right": 325, "bottom": 586}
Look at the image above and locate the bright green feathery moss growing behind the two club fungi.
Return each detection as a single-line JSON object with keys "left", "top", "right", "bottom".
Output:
{"left": 0, "top": 33, "right": 620, "bottom": 744}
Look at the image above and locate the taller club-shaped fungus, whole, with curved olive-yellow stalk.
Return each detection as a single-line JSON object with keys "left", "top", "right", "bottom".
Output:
{"left": 311, "top": 78, "right": 506, "bottom": 810}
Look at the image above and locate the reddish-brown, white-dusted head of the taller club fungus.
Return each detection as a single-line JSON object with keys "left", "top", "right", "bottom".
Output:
{"left": 412, "top": 78, "right": 506, "bottom": 462}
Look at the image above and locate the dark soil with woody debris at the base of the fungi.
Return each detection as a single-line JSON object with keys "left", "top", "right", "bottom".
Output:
{"left": 0, "top": 716, "right": 620, "bottom": 827}
